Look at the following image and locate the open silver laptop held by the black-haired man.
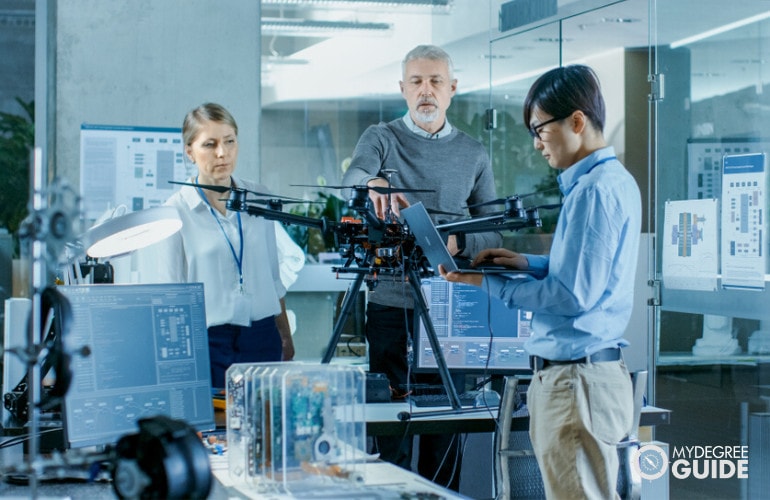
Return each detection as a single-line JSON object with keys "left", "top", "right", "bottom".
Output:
{"left": 401, "top": 202, "right": 522, "bottom": 275}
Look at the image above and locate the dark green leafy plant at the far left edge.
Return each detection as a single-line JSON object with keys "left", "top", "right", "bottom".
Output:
{"left": 0, "top": 97, "right": 35, "bottom": 255}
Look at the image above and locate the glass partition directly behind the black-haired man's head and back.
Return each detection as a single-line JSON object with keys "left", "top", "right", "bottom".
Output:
{"left": 489, "top": 0, "right": 654, "bottom": 382}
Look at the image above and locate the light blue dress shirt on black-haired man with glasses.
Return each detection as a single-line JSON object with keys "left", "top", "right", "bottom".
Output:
{"left": 485, "top": 147, "right": 642, "bottom": 360}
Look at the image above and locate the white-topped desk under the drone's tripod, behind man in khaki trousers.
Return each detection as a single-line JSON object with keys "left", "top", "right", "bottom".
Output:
{"left": 365, "top": 403, "right": 671, "bottom": 436}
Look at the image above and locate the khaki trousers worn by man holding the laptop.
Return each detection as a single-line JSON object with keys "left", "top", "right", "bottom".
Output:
{"left": 527, "top": 361, "right": 634, "bottom": 500}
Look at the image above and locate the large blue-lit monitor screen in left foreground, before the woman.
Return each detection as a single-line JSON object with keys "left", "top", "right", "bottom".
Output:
{"left": 58, "top": 283, "right": 214, "bottom": 448}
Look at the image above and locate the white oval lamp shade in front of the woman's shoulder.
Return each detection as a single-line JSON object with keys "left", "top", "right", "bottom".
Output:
{"left": 83, "top": 206, "right": 182, "bottom": 259}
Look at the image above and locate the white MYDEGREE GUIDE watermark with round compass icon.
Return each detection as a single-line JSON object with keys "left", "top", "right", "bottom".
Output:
{"left": 632, "top": 444, "right": 749, "bottom": 480}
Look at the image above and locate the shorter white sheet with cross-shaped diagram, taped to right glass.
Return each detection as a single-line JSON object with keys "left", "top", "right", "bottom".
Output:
{"left": 662, "top": 198, "right": 719, "bottom": 291}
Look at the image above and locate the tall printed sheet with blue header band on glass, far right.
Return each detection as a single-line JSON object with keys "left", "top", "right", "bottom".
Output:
{"left": 722, "top": 153, "right": 767, "bottom": 290}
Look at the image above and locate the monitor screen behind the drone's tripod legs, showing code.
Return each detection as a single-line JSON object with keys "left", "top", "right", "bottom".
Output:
{"left": 414, "top": 278, "right": 532, "bottom": 373}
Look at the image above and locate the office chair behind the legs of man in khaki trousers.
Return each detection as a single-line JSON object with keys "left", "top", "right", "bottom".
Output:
{"left": 495, "top": 370, "right": 647, "bottom": 500}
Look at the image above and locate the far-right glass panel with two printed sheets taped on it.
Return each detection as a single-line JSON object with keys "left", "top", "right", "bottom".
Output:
{"left": 655, "top": 0, "right": 770, "bottom": 498}
